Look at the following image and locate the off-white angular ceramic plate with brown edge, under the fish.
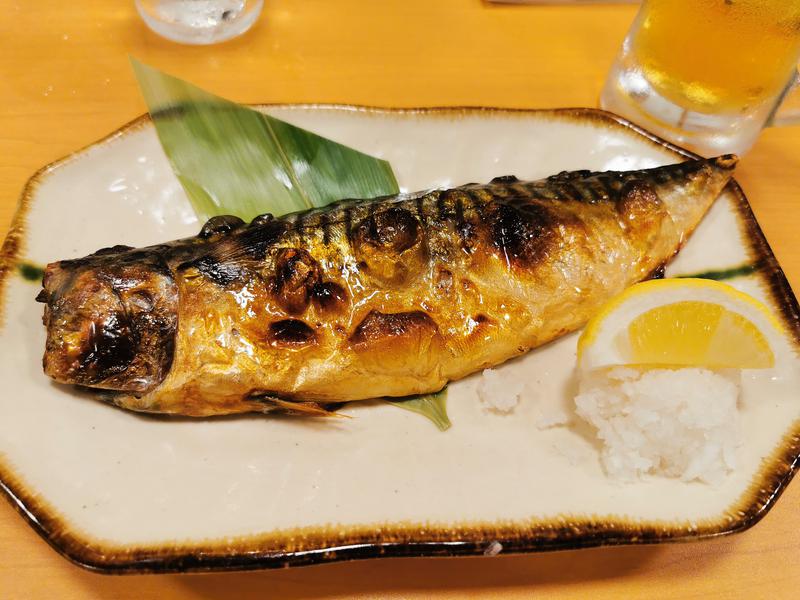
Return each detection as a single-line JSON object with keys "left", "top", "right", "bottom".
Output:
{"left": 0, "top": 106, "right": 800, "bottom": 571}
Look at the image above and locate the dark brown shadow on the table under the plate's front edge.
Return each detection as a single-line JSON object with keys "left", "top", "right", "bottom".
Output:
{"left": 171, "top": 540, "right": 730, "bottom": 600}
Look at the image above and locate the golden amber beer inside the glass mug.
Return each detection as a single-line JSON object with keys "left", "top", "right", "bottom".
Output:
{"left": 629, "top": 0, "right": 800, "bottom": 113}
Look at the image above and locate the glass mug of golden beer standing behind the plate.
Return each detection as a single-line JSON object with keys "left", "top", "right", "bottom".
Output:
{"left": 600, "top": 0, "right": 800, "bottom": 156}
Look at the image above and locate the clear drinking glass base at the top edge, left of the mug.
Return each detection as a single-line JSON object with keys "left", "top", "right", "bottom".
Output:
{"left": 135, "top": 0, "right": 264, "bottom": 44}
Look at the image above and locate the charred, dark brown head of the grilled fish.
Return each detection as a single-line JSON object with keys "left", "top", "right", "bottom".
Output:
{"left": 37, "top": 251, "right": 178, "bottom": 394}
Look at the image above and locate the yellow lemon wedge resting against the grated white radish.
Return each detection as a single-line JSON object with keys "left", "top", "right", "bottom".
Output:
{"left": 578, "top": 279, "right": 784, "bottom": 369}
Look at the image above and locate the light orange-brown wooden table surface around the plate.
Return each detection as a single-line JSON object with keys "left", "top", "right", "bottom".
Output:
{"left": 0, "top": 0, "right": 800, "bottom": 600}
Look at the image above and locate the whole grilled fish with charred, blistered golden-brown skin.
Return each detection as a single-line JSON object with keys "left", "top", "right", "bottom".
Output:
{"left": 39, "top": 155, "right": 737, "bottom": 416}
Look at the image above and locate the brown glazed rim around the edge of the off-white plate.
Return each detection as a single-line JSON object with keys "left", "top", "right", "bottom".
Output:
{"left": 0, "top": 103, "right": 800, "bottom": 573}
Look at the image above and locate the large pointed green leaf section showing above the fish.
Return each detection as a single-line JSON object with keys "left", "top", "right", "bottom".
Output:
{"left": 131, "top": 59, "right": 399, "bottom": 220}
